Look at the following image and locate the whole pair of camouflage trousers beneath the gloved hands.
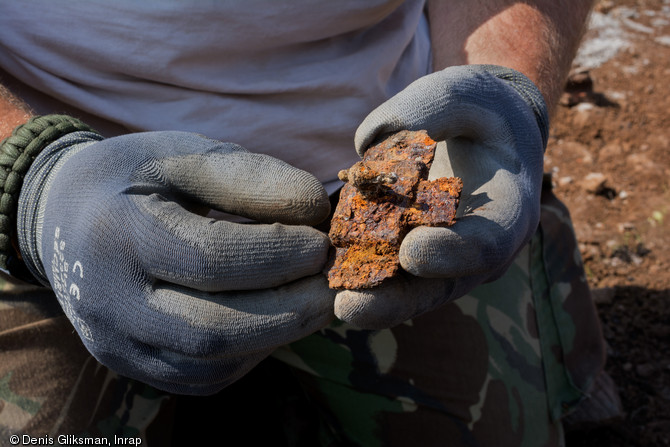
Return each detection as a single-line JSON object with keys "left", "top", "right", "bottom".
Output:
{"left": 0, "top": 186, "right": 604, "bottom": 447}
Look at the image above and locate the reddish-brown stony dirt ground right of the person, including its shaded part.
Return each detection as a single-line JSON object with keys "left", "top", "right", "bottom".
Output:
{"left": 545, "top": 0, "right": 670, "bottom": 447}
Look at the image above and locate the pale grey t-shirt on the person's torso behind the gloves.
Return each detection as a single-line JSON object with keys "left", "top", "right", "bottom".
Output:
{"left": 0, "top": 0, "right": 431, "bottom": 186}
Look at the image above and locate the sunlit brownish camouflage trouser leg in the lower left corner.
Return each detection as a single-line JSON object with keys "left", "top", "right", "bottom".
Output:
{"left": 0, "top": 278, "right": 174, "bottom": 446}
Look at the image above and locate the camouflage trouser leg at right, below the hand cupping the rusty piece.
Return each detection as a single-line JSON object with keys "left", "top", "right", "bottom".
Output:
{"left": 274, "top": 184, "right": 604, "bottom": 447}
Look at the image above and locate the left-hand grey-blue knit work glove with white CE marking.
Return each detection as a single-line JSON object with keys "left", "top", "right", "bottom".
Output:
{"left": 18, "top": 132, "right": 334, "bottom": 394}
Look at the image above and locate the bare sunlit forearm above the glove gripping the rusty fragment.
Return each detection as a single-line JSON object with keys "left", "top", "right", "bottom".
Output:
{"left": 428, "top": 0, "right": 593, "bottom": 113}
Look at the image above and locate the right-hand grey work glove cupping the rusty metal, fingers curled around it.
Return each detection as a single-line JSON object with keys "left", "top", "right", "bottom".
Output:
{"left": 335, "top": 65, "right": 548, "bottom": 329}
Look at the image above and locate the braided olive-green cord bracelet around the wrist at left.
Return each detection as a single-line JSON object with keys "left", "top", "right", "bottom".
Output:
{"left": 0, "top": 115, "right": 95, "bottom": 280}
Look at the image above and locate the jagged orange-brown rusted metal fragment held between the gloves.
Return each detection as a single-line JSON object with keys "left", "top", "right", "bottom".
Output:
{"left": 328, "top": 131, "right": 463, "bottom": 289}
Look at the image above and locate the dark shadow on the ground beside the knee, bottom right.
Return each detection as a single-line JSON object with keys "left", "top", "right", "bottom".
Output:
{"left": 567, "top": 286, "right": 670, "bottom": 447}
